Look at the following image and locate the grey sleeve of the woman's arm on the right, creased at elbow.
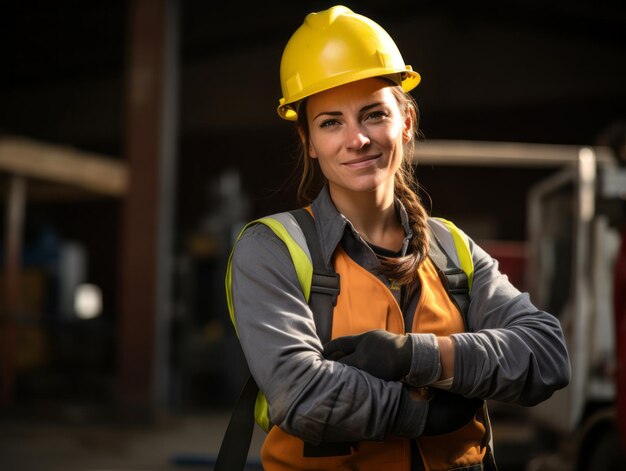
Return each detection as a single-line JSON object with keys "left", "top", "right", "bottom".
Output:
{"left": 451, "top": 231, "right": 570, "bottom": 406}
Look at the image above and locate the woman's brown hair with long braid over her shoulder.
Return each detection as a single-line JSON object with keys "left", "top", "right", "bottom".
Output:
{"left": 296, "top": 81, "right": 429, "bottom": 284}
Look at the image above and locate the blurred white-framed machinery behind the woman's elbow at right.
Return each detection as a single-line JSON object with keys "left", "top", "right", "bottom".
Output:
{"left": 528, "top": 148, "right": 626, "bottom": 471}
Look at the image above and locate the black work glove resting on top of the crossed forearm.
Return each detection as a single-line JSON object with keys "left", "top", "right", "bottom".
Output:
{"left": 324, "top": 330, "right": 413, "bottom": 381}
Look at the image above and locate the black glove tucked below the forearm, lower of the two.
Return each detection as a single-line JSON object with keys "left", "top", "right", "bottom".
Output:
{"left": 422, "top": 388, "right": 483, "bottom": 436}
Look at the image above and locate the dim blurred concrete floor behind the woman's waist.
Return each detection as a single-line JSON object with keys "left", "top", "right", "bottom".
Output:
{"left": 0, "top": 411, "right": 532, "bottom": 471}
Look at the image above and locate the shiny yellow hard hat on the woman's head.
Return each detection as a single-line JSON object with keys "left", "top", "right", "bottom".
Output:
{"left": 278, "top": 5, "right": 420, "bottom": 121}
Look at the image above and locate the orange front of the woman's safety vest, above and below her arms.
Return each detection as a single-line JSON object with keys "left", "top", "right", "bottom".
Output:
{"left": 261, "top": 247, "right": 487, "bottom": 471}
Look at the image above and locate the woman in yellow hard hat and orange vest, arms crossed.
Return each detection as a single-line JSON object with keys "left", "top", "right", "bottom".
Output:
{"left": 227, "top": 6, "right": 569, "bottom": 471}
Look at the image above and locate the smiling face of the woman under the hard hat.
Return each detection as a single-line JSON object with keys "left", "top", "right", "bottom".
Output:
{"left": 306, "top": 78, "right": 413, "bottom": 199}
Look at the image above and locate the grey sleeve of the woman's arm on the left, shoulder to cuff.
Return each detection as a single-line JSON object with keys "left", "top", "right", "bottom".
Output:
{"left": 231, "top": 224, "right": 428, "bottom": 444}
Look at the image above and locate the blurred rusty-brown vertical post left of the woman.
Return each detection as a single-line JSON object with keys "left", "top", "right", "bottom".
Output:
{"left": 118, "top": 0, "right": 177, "bottom": 413}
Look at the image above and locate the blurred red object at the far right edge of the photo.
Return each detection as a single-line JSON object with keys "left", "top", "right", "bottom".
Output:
{"left": 613, "top": 225, "right": 626, "bottom": 449}
